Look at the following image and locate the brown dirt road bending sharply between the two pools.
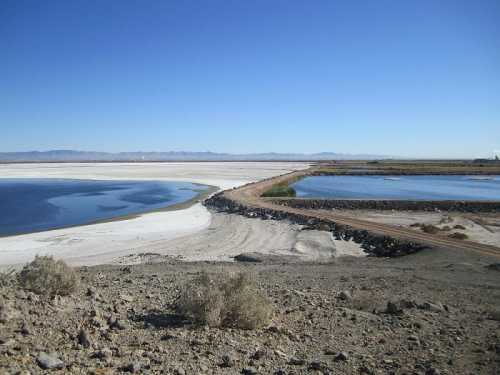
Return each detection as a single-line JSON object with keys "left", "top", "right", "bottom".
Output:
{"left": 224, "top": 170, "right": 500, "bottom": 258}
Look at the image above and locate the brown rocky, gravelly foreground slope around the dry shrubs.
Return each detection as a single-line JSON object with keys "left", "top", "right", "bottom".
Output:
{"left": 0, "top": 250, "right": 500, "bottom": 375}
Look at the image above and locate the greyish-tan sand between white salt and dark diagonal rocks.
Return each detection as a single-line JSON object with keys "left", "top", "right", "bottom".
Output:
{"left": 115, "top": 212, "right": 365, "bottom": 264}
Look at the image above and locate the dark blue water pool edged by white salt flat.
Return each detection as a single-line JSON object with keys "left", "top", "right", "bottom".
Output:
{"left": 0, "top": 179, "right": 208, "bottom": 236}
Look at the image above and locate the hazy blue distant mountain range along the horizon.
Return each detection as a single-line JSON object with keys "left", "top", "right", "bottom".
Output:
{"left": 0, "top": 150, "right": 390, "bottom": 162}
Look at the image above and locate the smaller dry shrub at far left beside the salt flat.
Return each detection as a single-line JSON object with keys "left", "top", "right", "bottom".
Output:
{"left": 19, "top": 255, "right": 78, "bottom": 296}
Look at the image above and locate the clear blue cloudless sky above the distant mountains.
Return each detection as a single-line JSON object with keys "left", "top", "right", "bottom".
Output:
{"left": 0, "top": 0, "right": 500, "bottom": 157}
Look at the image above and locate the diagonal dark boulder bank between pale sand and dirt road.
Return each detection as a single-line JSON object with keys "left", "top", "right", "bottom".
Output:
{"left": 204, "top": 193, "right": 426, "bottom": 257}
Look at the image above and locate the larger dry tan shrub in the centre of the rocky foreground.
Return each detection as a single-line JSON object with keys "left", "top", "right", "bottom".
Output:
{"left": 177, "top": 272, "right": 273, "bottom": 329}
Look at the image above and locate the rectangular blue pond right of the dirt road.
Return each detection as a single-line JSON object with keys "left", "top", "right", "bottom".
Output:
{"left": 291, "top": 176, "right": 500, "bottom": 201}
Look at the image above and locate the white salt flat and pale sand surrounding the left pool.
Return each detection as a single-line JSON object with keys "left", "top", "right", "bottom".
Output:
{"left": 0, "top": 162, "right": 362, "bottom": 266}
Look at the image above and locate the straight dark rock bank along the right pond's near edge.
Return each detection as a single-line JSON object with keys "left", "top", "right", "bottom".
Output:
{"left": 273, "top": 198, "right": 500, "bottom": 213}
